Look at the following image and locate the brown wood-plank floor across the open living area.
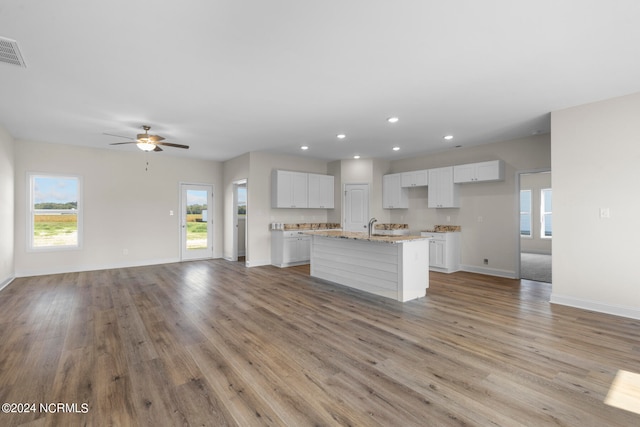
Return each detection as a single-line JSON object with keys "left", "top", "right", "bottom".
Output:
{"left": 0, "top": 260, "right": 640, "bottom": 426}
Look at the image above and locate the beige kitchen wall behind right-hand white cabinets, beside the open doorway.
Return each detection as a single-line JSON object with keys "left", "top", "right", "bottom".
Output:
{"left": 391, "top": 134, "right": 551, "bottom": 277}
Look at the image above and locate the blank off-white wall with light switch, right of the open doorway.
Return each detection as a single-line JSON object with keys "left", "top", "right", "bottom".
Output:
{"left": 551, "top": 93, "right": 640, "bottom": 319}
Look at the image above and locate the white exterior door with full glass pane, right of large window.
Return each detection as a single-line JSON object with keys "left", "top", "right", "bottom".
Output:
{"left": 180, "top": 184, "right": 213, "bottom": 261}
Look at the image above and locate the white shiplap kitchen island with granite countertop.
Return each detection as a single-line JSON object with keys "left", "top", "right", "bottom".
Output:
{"left": 308, "top": 230, "right": 429, "bottom": 302}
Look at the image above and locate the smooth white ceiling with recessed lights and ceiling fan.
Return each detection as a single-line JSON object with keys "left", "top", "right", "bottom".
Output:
{"left": 0, "top": 0, "right": 640, "bottom": 160}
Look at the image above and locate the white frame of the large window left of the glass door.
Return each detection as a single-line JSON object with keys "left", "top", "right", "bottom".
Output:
{"left": 26, "top": 172, "right": 84, "bottom": 252}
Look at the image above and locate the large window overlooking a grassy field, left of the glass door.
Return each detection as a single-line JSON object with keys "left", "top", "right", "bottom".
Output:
{"left": 28, "top": 175, "right": 82, "bottom": 250}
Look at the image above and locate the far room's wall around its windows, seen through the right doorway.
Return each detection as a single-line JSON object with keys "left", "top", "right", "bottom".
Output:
{"left": 520, "top": 172, "right": 552, "bottom": 254}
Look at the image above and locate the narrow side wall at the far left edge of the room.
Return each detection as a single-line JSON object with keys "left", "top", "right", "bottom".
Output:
{"left": 0, "top": 126, "right": 15, "bottom": 289}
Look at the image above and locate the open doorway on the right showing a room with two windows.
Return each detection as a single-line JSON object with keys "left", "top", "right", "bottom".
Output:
{"left": 518, "top": 170, "right": 553, "bottom": 283}
